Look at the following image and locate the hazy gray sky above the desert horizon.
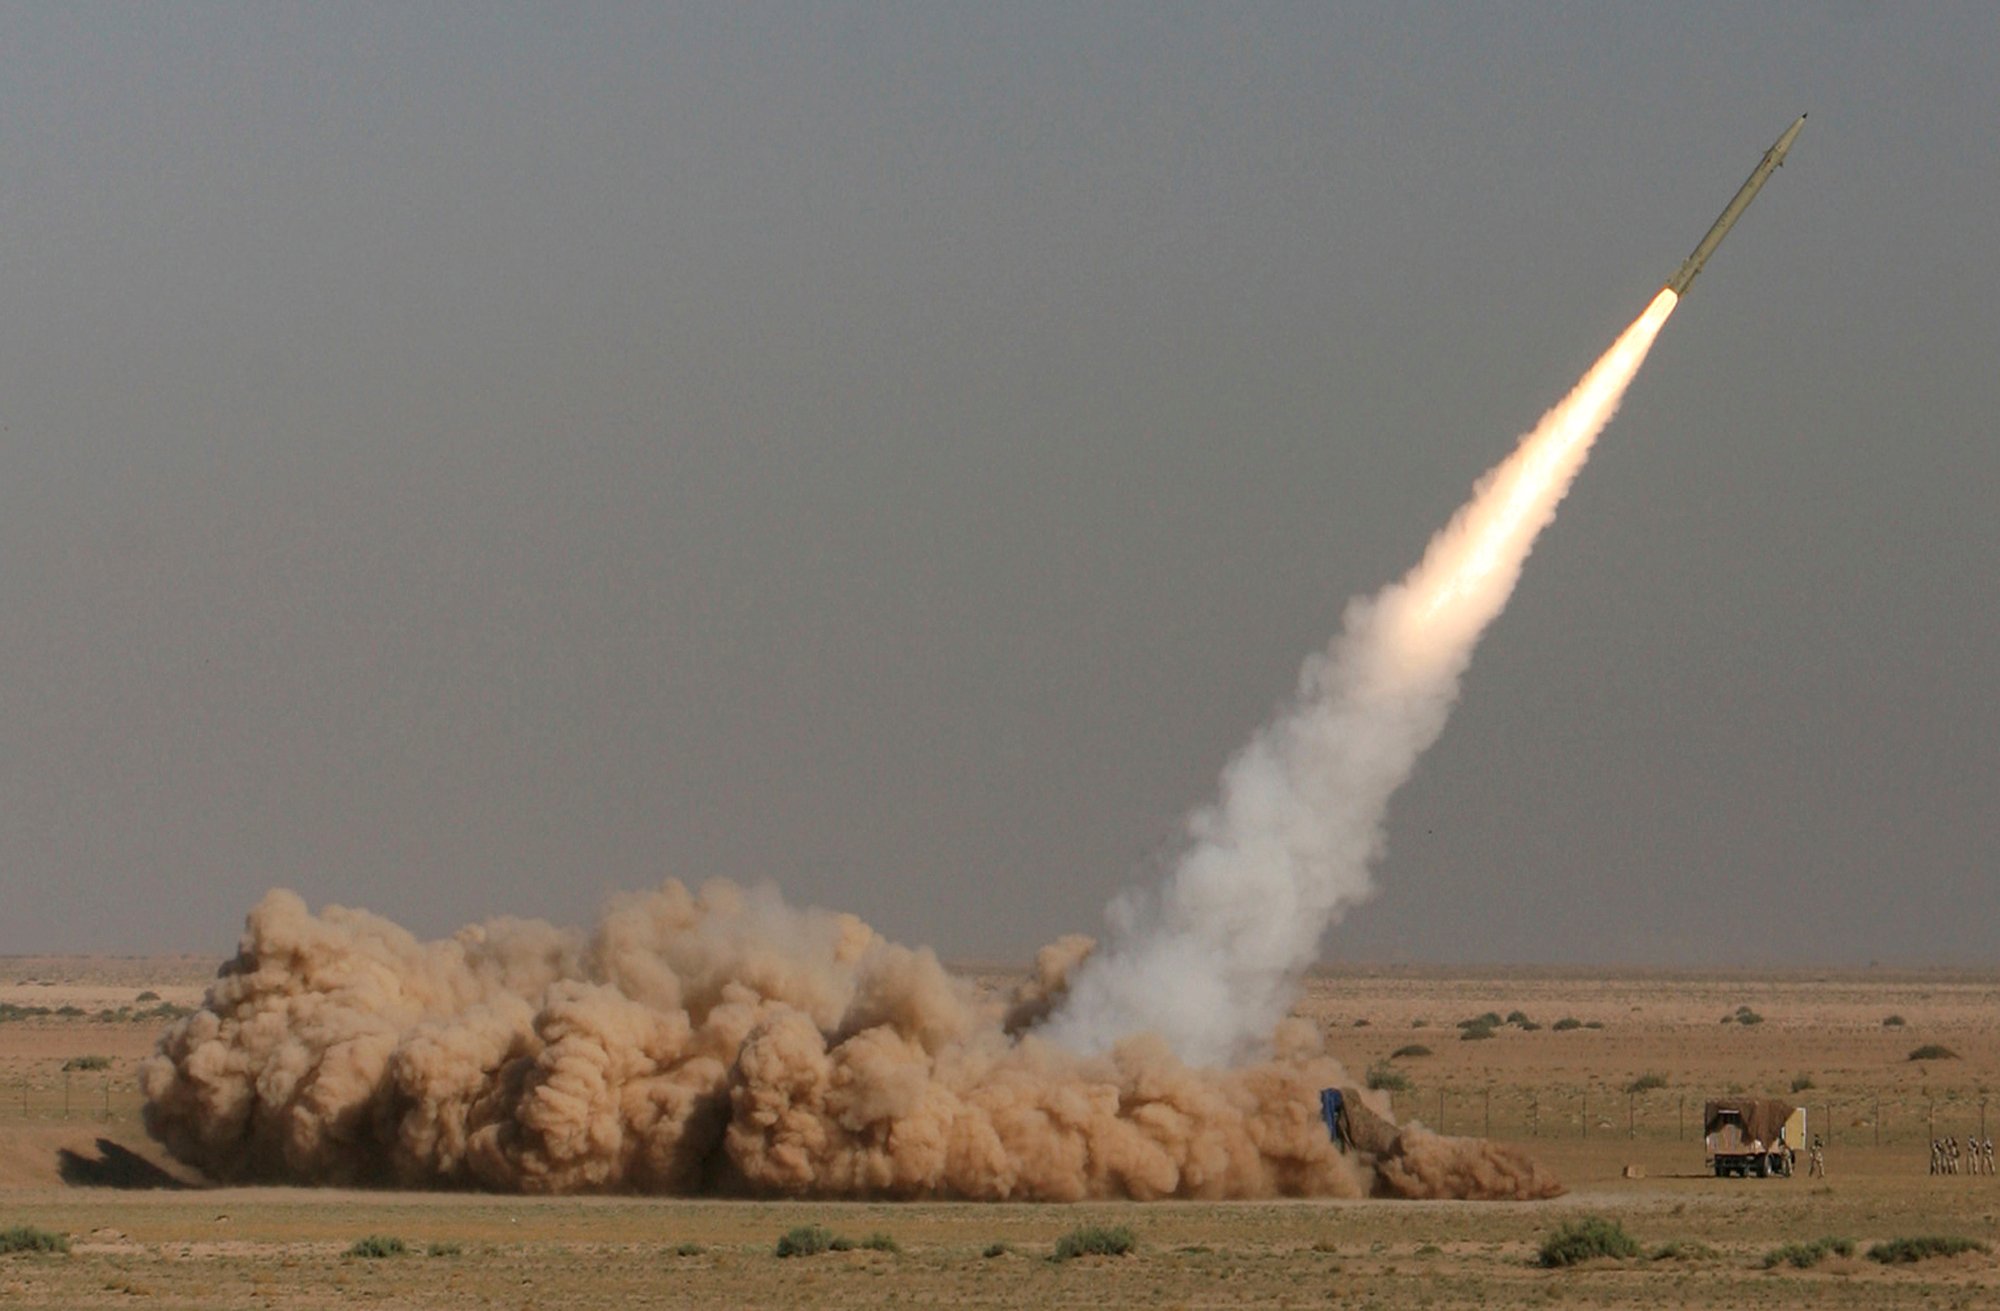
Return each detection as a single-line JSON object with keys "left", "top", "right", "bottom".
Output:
{"left": 0, "top": 0, "right": 2000, "bottom": 963}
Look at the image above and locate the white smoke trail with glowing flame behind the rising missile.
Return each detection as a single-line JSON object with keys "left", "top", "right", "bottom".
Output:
{"left": 1042, "top": 290, "right": 1678, "bottom": 1065}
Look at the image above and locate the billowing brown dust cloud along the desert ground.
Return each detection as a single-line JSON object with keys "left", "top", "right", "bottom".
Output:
{"left": 140, "top": 883, "right": 1556, "bottom": 1201}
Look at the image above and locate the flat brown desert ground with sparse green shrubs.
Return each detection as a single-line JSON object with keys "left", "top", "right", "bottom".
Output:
{"left": 0, "top": 957, "right": 2000, "bottom": 1309}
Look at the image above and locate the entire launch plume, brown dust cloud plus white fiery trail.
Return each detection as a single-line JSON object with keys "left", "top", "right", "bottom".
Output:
{"left": 140, "top": 292, "right": 1674, "bottom": 1201}
